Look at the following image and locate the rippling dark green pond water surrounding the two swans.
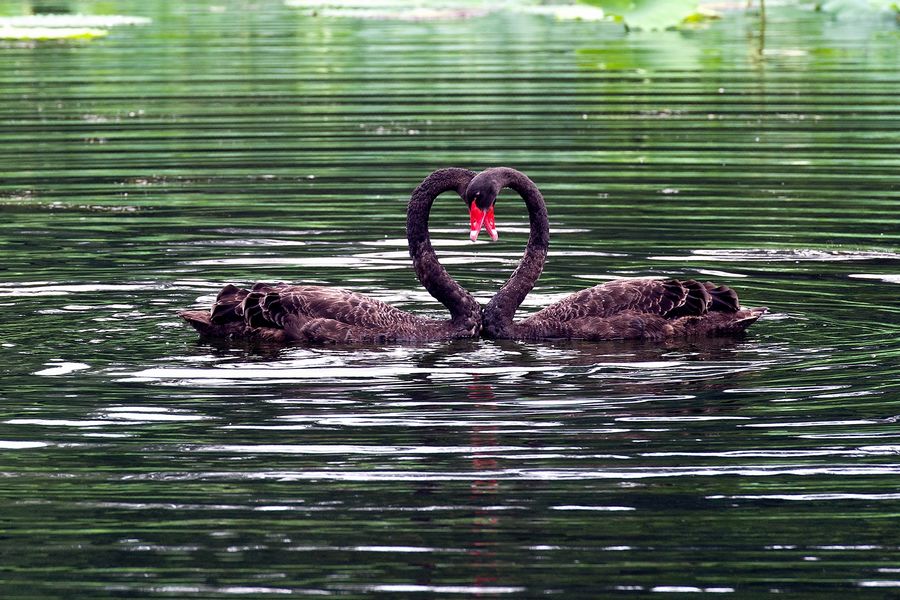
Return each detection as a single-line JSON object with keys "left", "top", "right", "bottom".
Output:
{"left": 0, "top": 2, "right": 900, "bottom": 598}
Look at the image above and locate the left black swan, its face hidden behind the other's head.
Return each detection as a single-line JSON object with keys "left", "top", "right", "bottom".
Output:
{"left": 179, "top": 168, "right": 481, "bottom": 343}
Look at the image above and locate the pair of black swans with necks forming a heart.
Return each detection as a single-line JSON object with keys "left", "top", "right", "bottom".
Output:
{"left": 179, "top": 167, "right": 766, "bottom": 343}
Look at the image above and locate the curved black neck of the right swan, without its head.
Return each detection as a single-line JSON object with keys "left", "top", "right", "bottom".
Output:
{"left": 477, "top": 167, "right": 550, "bottom": 338}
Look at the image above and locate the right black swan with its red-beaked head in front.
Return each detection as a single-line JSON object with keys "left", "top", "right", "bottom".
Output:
{"left": 465, "top": 167, "right": 766, "bottom": 340}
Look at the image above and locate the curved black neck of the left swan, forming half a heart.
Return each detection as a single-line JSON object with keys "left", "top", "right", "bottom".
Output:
{"left": 406, "top": 168, "right": 481, "bottom": 321}
